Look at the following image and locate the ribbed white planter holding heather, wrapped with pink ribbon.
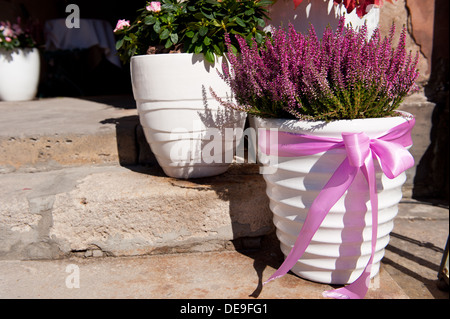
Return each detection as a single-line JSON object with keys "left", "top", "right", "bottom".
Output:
{"left": 255, "top": 117, "right": 412, "bottom": 284}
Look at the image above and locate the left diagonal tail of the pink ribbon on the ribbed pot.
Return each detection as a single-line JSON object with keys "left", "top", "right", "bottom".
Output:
{"left": 264, "top": 158, "right": 358, "bottom": 285}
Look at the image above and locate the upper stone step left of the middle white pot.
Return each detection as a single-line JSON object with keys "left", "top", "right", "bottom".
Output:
{"left": 0, "top": 96, "right": 147, "bottom": 173}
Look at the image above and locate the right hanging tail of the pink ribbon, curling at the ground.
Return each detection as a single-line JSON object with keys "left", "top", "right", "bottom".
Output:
{"left": 323, "top": 156, "right": 378, "bottom": 299}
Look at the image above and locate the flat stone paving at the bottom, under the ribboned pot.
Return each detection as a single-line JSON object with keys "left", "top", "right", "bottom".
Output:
{"left": 0, "top": 250, "right": 408, "bottom": 302}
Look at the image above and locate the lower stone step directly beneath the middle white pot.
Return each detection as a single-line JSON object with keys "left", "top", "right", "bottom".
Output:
{"left": 0, "top": 165, "right": 273, "bottom": 259}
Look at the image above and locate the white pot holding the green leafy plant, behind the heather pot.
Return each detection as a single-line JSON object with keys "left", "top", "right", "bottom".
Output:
{"left": 131, "top": 53, "right": 246, "bottom": 179}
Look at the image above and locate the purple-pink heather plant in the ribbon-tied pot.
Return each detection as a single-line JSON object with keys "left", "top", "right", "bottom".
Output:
{"left": 216, "top": 18, "right": 419, "bottom": 121}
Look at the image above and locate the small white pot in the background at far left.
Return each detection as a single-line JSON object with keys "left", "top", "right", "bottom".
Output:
{"left": 0, "top": 48, "right": 40, "bottom": 101}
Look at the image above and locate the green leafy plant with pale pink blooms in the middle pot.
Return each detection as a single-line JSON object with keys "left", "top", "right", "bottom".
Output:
{"left": 115, "top": 0, "right": 272, "bottom": 62}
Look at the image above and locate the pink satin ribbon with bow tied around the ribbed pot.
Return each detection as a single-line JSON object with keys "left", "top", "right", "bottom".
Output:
{"left": 259, "top": 118, "right": 415, "bottom": 299}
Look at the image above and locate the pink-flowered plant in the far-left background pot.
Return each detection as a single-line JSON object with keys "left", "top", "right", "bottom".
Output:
{"left": 0, "top": 19, "right": 36, "bottom": 50}
